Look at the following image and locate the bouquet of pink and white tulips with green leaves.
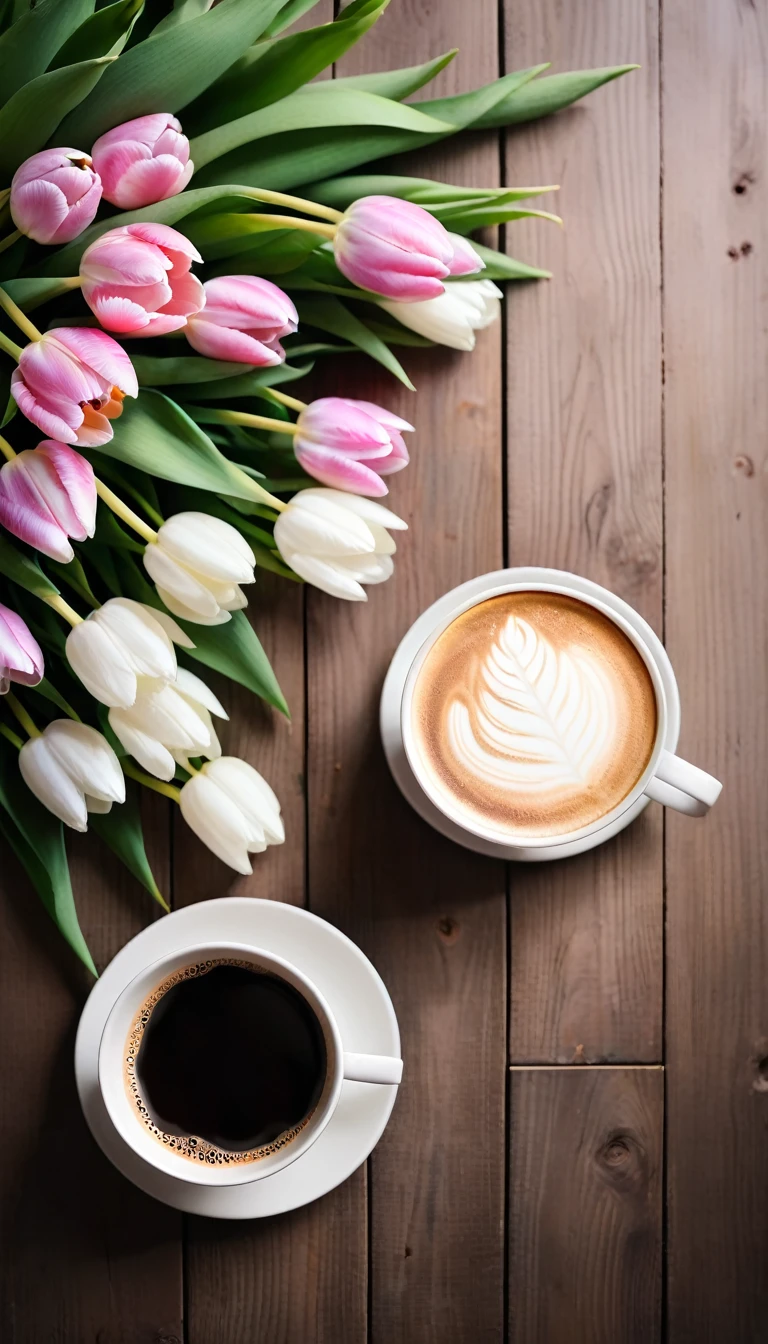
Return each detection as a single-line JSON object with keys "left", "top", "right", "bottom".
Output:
{"left": 0, "top": 0, "right": 631, "bottom": 970}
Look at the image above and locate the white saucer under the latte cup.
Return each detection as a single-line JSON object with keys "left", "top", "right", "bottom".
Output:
{"left": 379, "top": 567, "right": 681, "bottom": 863}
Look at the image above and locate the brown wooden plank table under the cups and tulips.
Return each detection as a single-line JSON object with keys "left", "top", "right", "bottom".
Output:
{"left": 0, "top": 0, "right": 768, "bottom": 1344}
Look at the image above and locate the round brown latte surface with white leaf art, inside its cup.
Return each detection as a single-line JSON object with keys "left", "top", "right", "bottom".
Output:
{"left": 412, "top": 591, "right": 656, "bottom": 840}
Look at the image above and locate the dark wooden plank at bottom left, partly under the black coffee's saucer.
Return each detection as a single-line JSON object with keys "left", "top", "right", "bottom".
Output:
{"left": 0, "top": 800, "right": 182, "bottom": 1344}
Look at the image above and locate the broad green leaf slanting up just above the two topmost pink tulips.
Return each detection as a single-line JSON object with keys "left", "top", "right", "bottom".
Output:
{"left": 55, "top": 0, "right": 286, "bottom": 145}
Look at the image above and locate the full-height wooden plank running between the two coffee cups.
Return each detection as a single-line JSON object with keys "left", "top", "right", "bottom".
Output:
{"left": 308, "top": 0, "right": 506, "bottom": 1344}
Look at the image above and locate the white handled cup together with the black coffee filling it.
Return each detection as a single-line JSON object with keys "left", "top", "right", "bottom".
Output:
{"left": 98, "top": 942, "right": 402, "bottom": 1187}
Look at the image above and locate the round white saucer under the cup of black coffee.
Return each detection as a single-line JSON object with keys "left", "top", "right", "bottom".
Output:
{"left": 75, "top": 896, "right": 399, "bottom": 1218}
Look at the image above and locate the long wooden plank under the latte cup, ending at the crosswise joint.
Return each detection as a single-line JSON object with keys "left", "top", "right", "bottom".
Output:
{"left": 504, "top": 0, "right": 662, "bottom": 1063}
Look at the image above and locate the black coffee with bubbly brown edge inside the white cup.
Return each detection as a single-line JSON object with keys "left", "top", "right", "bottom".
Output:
{"left": 126, "top": 961, "right": 325, "bottom": 1164}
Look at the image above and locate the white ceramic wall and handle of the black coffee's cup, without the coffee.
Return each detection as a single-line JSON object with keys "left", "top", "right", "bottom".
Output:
{"left": 98, "top": 942, "right": 402, "bottom": 1187}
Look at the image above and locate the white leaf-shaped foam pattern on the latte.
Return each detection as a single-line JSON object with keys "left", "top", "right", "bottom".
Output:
{"left": 447, "top": 616, "right": 617, "bottom": 794}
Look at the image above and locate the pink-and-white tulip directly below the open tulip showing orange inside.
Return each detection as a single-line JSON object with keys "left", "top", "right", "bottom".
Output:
{"left": 0, "top": 438, "right": 95, "bottom": 564}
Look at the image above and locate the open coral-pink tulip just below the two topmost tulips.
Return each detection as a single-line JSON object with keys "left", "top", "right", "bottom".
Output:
{"left": 79, "top": 224, "right": 206, "bottom": 336}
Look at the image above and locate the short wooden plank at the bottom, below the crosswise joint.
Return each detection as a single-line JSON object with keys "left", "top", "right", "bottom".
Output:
{"left": 508, "top": 1067, "right": 663, "bottom": 1344}
